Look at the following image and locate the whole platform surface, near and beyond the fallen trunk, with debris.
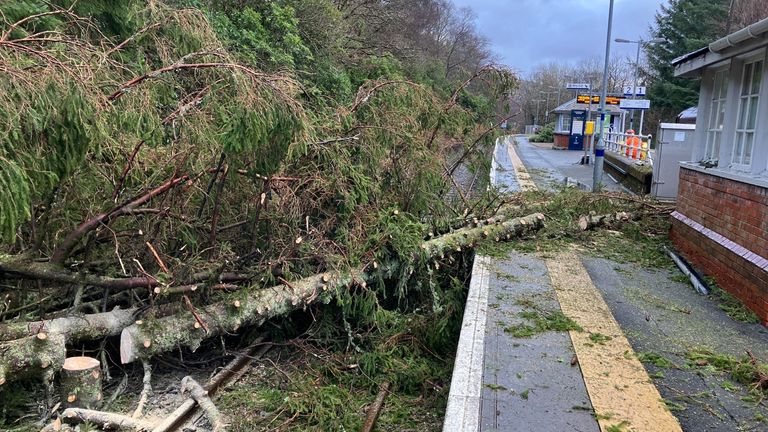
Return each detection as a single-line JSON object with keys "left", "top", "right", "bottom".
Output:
{"left": 443, "top": 136, "right": 768, "bottom": 431}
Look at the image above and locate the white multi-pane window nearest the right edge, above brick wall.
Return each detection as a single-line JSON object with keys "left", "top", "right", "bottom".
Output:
{"left": 731, "top": 54, "right": 765, "bottom": 171}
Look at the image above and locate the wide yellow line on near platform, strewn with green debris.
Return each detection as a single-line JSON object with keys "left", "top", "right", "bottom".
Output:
{"left": 546, "top": 251, "right": 682, "bottom": 432}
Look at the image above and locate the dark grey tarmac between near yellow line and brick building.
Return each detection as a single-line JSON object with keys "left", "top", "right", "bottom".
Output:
{"left": 582, "top": 258, "right": 768, "bottom": 432}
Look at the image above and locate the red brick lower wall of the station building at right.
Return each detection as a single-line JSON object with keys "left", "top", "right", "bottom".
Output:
{"left": 670, "top": 167, "right": 768, "bottom": 324}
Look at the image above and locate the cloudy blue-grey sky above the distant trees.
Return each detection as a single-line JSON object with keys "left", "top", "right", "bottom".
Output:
{"left": 453, "top": 0, "right": 667, "bottom": 75}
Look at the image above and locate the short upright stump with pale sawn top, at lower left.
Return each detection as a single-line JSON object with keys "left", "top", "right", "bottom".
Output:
{"left": 61, "top": 357, "right": 103, "bottom": 408}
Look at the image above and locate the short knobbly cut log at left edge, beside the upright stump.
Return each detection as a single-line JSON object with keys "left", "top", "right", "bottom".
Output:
{"left": 0, "top": 333, "right": 66, "bottom": 385}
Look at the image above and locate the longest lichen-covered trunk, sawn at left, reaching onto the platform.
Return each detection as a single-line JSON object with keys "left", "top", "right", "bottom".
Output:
{"left": 120, "top": 213, "right": 544, "bottom": 363}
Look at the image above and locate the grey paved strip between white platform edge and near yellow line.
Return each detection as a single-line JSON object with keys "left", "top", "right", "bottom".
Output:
{"left": 480, "top": 252, "right": 599, "bottom": 432}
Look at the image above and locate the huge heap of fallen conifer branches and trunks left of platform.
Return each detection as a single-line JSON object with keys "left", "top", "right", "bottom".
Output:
{"left": 0, "top": 1, "right": 520, "bottom": 422}
